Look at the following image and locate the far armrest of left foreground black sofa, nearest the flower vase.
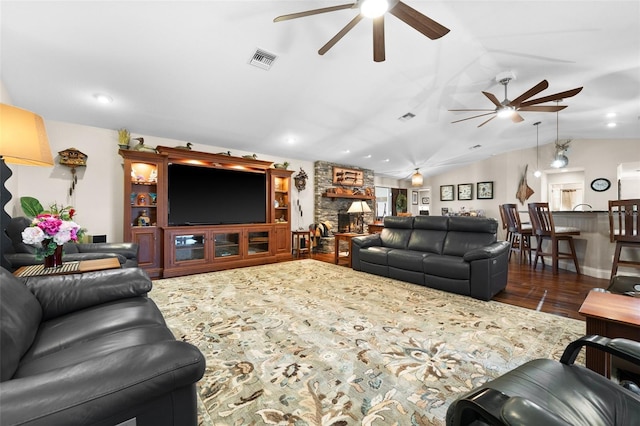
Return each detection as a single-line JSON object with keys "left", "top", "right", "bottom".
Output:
{"left": 22, "top": 268, "right": 152, "bottom": 320}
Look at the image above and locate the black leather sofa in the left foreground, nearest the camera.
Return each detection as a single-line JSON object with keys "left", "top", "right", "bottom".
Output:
{"left": 0, "top": 268, "right": 205, "bottom": 426}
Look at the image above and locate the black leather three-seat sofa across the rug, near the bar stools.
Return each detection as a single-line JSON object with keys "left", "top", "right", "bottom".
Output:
{"left": 351, "top": 216, "right": 509, "bottom": 300}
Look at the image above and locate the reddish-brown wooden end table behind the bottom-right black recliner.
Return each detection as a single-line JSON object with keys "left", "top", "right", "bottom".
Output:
{"left": 578, "top": 291, "right": 640, "bottom": 377}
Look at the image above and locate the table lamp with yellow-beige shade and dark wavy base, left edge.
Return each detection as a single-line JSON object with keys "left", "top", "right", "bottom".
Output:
{"left": 0, "top": 103, "right": 53, "bottom": 269}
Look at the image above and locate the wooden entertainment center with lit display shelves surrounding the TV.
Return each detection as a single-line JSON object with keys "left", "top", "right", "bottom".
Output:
{"left": 119, "top": 146, "right": 293, "bottom": 278}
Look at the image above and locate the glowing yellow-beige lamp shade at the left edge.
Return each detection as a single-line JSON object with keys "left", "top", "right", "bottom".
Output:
{"left": 0, "top": 104, "right": 53, "bottom": 166}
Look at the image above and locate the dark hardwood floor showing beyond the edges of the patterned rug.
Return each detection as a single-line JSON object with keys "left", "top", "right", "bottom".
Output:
{"left": 292, "top": 253, "right": 609, "bottom": 320}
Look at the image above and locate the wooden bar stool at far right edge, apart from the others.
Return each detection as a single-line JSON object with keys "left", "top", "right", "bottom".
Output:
{"left": 609, "top": 199, "right": 640, "bottom": 280}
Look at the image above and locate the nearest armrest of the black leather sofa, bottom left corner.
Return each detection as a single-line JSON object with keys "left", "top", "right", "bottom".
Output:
{"left": 0, "top": 340, "right": 205, "bottom": 425}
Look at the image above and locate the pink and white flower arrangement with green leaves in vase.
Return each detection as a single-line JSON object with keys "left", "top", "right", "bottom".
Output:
{"left": 22, "top": 197, "right": 82, "bottom": 256}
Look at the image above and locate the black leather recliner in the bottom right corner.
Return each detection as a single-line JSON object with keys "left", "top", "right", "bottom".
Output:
{"left": 447, "top": 336, "right": 640, "bottom": 426}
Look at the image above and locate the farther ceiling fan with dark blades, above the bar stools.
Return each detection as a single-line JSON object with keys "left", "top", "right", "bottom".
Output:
{"left": 449, "top": 77, "right": 582, "bottom": 127}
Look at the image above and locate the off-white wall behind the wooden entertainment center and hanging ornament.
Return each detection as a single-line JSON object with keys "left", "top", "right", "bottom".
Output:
{"left": 6, "top": 118, "right": 314, "bottom": 241}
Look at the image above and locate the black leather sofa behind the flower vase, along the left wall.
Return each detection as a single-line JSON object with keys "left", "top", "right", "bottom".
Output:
{"left": 3, "top": 217, "right": 138, "bottom": 271}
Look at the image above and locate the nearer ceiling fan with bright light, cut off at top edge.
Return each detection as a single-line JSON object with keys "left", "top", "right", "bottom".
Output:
{"left": 273, "top": 0, "right": 449, "bottom": 62}
